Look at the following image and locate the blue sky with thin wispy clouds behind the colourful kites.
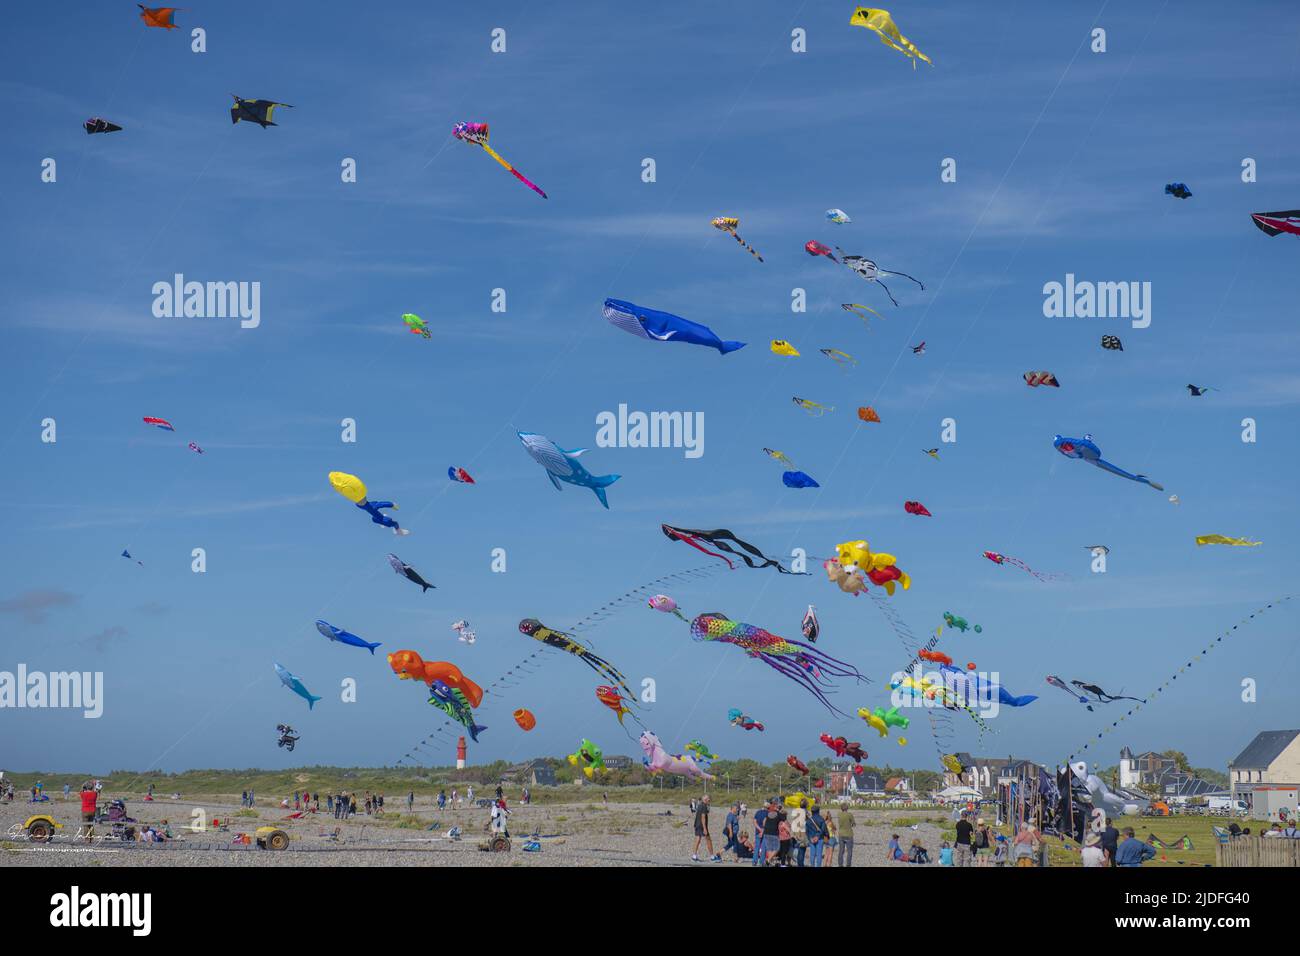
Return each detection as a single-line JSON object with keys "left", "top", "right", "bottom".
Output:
{"left": 0, "top": 1, "right": 1300, "bottom": 771}
